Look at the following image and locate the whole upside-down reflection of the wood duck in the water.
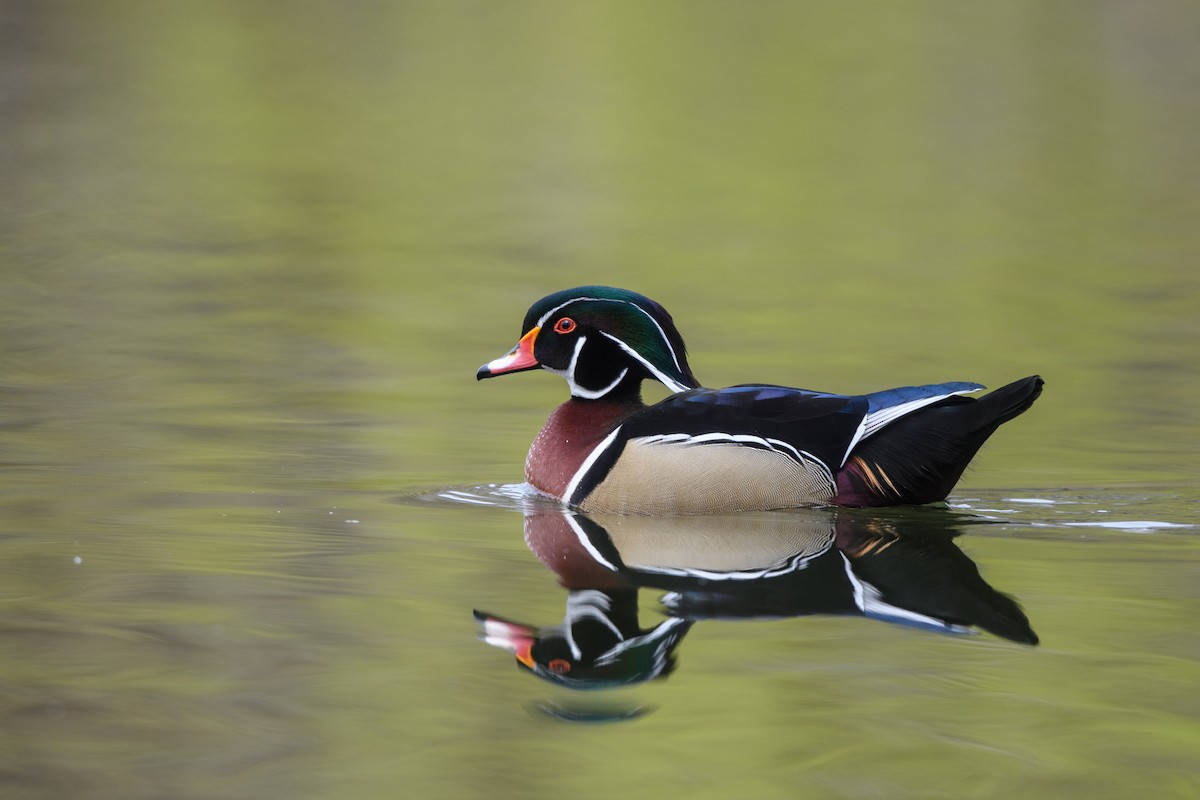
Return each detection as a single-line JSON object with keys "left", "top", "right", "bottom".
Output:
{"left": 475, "top": 507, "right": 1038, "bottom": 688}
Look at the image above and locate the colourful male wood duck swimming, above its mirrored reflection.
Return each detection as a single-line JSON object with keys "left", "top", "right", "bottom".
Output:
{"left": 476, "top": 287, "right": 1042, "bottom": 515}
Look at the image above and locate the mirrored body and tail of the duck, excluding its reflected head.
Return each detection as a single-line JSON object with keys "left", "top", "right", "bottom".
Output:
{"left": 524, "top": 504, "right": 1038, "bottom": 644}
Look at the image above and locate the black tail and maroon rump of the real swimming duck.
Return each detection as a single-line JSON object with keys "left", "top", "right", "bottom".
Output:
{"left": 835, "top": 375, "right": 1043, "bottom": 506}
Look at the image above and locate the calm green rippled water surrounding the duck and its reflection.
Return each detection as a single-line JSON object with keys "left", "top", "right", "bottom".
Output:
{"left": 0, "top": 0, "right": 1200, "bottom": 799}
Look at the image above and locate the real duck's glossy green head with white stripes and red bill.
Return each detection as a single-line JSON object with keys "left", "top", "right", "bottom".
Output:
{"left": 475, "top": 287, "right": 700, "bottom": 399}
